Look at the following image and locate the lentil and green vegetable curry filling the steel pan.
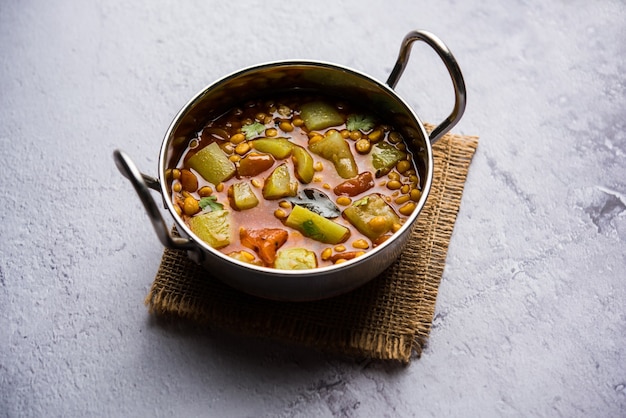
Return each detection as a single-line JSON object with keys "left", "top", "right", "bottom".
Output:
{"left": 166, "top": 94, "right": 421, "bottom": 270}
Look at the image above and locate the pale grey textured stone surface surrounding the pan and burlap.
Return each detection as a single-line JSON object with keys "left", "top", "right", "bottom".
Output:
{"left": 0, "top": 0, "right": 626, "bottom": 417}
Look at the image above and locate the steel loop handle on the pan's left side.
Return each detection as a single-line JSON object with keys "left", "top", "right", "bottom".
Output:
{"left": 113, "top": 150, "right": 197, "bottom": 250}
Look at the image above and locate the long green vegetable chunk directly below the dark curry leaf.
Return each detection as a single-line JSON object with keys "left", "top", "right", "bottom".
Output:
{"left": 285, "top": 205, "right": 350, "bottom": 244}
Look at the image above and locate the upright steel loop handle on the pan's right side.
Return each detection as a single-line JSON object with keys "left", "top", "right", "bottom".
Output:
{"left": 387, "top": 31, "right": 467, "bottom": 143}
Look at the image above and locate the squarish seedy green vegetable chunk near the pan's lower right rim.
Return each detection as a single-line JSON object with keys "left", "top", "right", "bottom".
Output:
{"left": 343, "top": 193, "right": 400, "bottom": 240}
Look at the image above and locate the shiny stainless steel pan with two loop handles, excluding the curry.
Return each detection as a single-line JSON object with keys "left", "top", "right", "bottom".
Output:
{"left": 114, "top": 31, "right": 466, "bottom": 301}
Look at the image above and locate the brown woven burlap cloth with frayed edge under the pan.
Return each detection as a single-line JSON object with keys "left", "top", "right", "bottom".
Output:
{"left": 146, "top": 127, "right": 478, "bottom": 363}
